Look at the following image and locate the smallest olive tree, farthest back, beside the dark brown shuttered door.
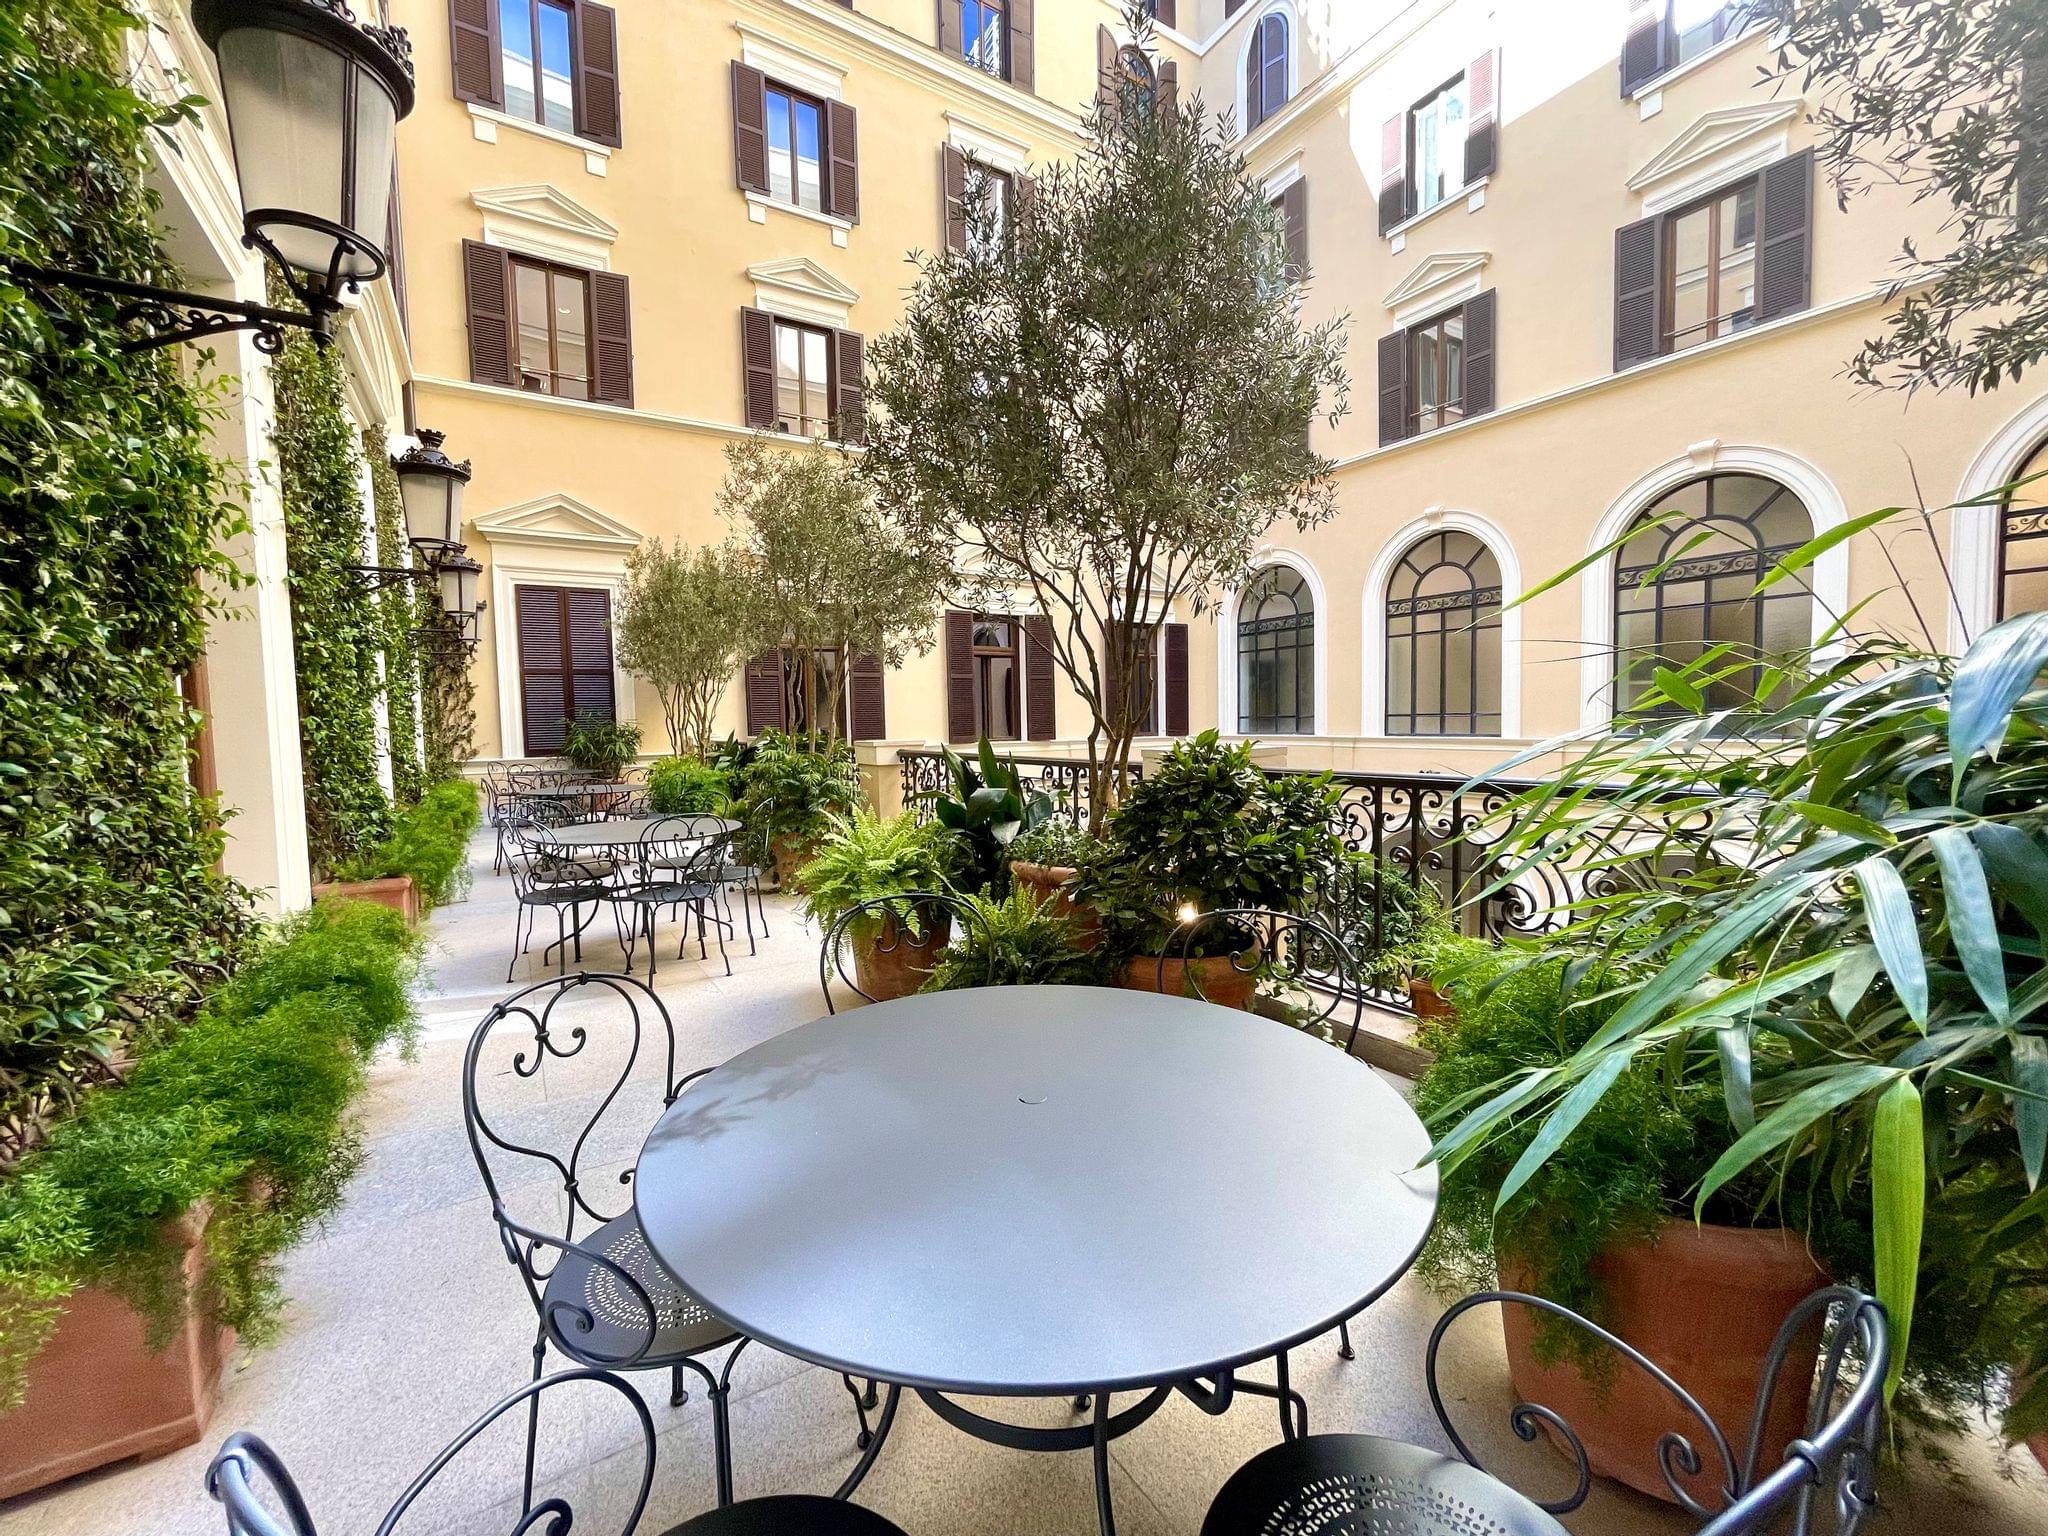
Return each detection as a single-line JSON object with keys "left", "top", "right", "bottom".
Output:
{"left": 618, "top": 539, "right": 752, "bottom": 758}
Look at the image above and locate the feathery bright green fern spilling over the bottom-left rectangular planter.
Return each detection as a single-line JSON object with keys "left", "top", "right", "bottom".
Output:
{"left": 0, "top": 901, "right": 422, "bottom": 1411}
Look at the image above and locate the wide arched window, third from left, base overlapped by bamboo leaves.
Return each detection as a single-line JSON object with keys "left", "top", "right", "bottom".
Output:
{"left": 1614, "top": 475, "right": 1812, "bottom": 711}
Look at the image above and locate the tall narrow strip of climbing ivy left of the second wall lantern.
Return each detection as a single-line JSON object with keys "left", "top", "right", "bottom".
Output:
{"left": 270, "top": 272, "right": 391, "bottom": 872}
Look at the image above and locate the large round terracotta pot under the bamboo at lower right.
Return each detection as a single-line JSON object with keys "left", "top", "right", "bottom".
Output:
{"left": 1501, "top": 1221, "right": 1827, "bottom": 1509}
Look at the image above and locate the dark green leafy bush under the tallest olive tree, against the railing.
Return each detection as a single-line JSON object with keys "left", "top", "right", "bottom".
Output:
{"left": 1075, "top": 731, "right": 1346, "bottom": 954}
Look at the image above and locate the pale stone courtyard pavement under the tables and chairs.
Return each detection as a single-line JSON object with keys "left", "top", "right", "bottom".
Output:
{"left": 0, "top": 840, "right": 2048, "bottom": 1536}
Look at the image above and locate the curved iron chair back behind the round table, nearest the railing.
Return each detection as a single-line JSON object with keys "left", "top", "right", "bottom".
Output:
{"left": 1155, "top": 907, "right": 1364, "bottom": 1051}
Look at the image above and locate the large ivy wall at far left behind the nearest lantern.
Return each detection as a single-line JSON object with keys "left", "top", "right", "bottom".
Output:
{"left": 0, "top": 0, "right": 246, "bottom": 1145}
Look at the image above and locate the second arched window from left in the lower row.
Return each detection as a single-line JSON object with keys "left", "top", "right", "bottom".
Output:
{"left": 1386, "top": 530, "right": 1501, "bottom": 735}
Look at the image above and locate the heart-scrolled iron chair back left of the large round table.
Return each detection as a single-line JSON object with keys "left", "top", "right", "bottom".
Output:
{"left": 463, "top": 973, "right": 711, "bottom": 1366}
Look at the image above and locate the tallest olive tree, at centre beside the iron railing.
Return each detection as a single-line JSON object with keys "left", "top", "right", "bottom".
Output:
{"left": 862, "top": 18, "right": 1348, "bottom": 825}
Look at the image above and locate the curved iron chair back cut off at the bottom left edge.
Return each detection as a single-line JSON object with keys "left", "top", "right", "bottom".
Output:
{"left": 207, "top": 1368, "right": 651, "bottom": 1536}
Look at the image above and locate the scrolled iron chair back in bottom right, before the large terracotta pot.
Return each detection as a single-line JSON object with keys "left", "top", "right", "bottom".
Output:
{"left": 1425, "top": 1286, "right": 1890, "bottom": 1536}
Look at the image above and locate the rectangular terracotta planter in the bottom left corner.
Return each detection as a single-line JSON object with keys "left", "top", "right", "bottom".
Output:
{"left": 0, "top": 1210, "right": 236, "bottom": 1499}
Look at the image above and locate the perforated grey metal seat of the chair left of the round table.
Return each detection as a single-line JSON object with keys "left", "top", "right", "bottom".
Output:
{"left": 541, "top": 1210, "right": 739, "bottom": 1364}
